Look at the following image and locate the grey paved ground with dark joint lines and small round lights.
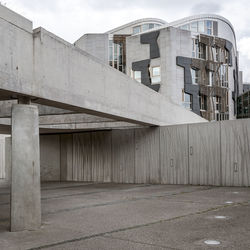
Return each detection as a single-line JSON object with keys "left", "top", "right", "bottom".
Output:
{"left": 0, "top": 183, "right": 250, "bottom": 250}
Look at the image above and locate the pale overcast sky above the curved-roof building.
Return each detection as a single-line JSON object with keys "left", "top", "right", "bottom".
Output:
{"left": 0, "top": 0, "right": 250, "bottom": 82}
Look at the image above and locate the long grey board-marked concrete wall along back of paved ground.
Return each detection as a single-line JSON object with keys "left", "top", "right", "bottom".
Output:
{"left": 37, "top": 119, "right": 250, "bottom": 186}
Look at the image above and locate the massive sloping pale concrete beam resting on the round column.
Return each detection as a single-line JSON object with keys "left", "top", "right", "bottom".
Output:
{"left": 0, "top": 6, "right": 204, "bottom": 125}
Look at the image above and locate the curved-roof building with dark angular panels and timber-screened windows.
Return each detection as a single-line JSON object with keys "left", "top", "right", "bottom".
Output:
{"left": 75, "top": 14, "right": 242, "bottom": 121}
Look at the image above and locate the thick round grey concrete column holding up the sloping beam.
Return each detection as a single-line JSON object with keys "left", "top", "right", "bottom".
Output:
{"left": 11, "top": 104, "right": 41, "bottom": 232}
